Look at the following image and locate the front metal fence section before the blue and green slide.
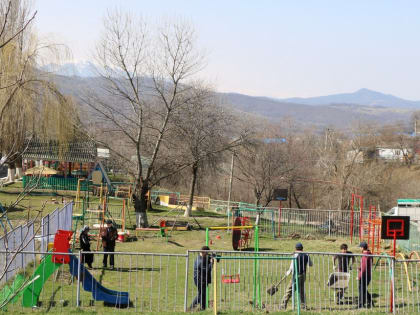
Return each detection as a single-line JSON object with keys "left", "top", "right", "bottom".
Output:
{"left": 0, "top": 252, "right": 187, "bottom": 313}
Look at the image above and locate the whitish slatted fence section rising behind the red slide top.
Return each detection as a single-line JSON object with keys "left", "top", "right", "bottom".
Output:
{"left": 40, "top": 202, "right": 73, "bottom": 252}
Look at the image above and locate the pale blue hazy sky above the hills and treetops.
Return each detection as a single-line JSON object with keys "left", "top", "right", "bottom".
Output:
{"left": 33, "top": 0, "right": 420, "bottom": 100}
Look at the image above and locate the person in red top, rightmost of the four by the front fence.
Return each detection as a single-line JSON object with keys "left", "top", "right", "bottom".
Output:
{"left": 358, "top": 242, "right": 374, "bottom": 308}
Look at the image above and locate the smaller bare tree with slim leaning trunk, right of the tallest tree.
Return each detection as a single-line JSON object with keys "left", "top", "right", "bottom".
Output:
{"left": 170, "top": 85, "right": 248, "bottom": 217}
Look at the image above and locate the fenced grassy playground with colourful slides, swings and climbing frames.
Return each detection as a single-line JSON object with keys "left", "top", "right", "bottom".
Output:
{"left": 0, "top": 181, "right": 420, "bottom": 314}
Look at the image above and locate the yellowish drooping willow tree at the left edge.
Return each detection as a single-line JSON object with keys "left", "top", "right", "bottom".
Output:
{"left": 0, "top": 1, "right": 77, "bottom": 180}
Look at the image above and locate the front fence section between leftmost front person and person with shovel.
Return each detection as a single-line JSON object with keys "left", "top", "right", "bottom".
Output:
{"left": 185, "top": 251, "right": 296, "bottom": 312}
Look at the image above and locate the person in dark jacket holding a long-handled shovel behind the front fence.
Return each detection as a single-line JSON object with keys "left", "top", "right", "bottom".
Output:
{"left": 281, "top": 243, "right": 313, "bottom": 309}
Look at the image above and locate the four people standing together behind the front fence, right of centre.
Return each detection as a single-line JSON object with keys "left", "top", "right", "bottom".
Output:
{"left": 189, "top": 242, "right": 374, "bottom": 310}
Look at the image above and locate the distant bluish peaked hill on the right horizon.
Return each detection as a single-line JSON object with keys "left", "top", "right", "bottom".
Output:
{"left": 279, "top": 89, "right": 420, "bottom": 109}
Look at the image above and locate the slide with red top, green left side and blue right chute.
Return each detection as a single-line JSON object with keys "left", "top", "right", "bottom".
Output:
{"left": 22, "top": 230, "right": 130, "bottom": 307}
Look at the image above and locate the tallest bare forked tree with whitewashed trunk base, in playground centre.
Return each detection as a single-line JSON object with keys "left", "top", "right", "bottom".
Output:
{"left": 83, "top": 11, "right": 212, "bottom": 226}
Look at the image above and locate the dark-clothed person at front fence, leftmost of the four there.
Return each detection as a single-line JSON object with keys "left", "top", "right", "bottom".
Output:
{"left": 189, "top": 246, "right": 213, "bottom": 311}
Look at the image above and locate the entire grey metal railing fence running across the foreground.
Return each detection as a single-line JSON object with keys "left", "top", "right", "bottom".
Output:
{"left": 0, "top": 251, "right": 420, "bottom": 314}
